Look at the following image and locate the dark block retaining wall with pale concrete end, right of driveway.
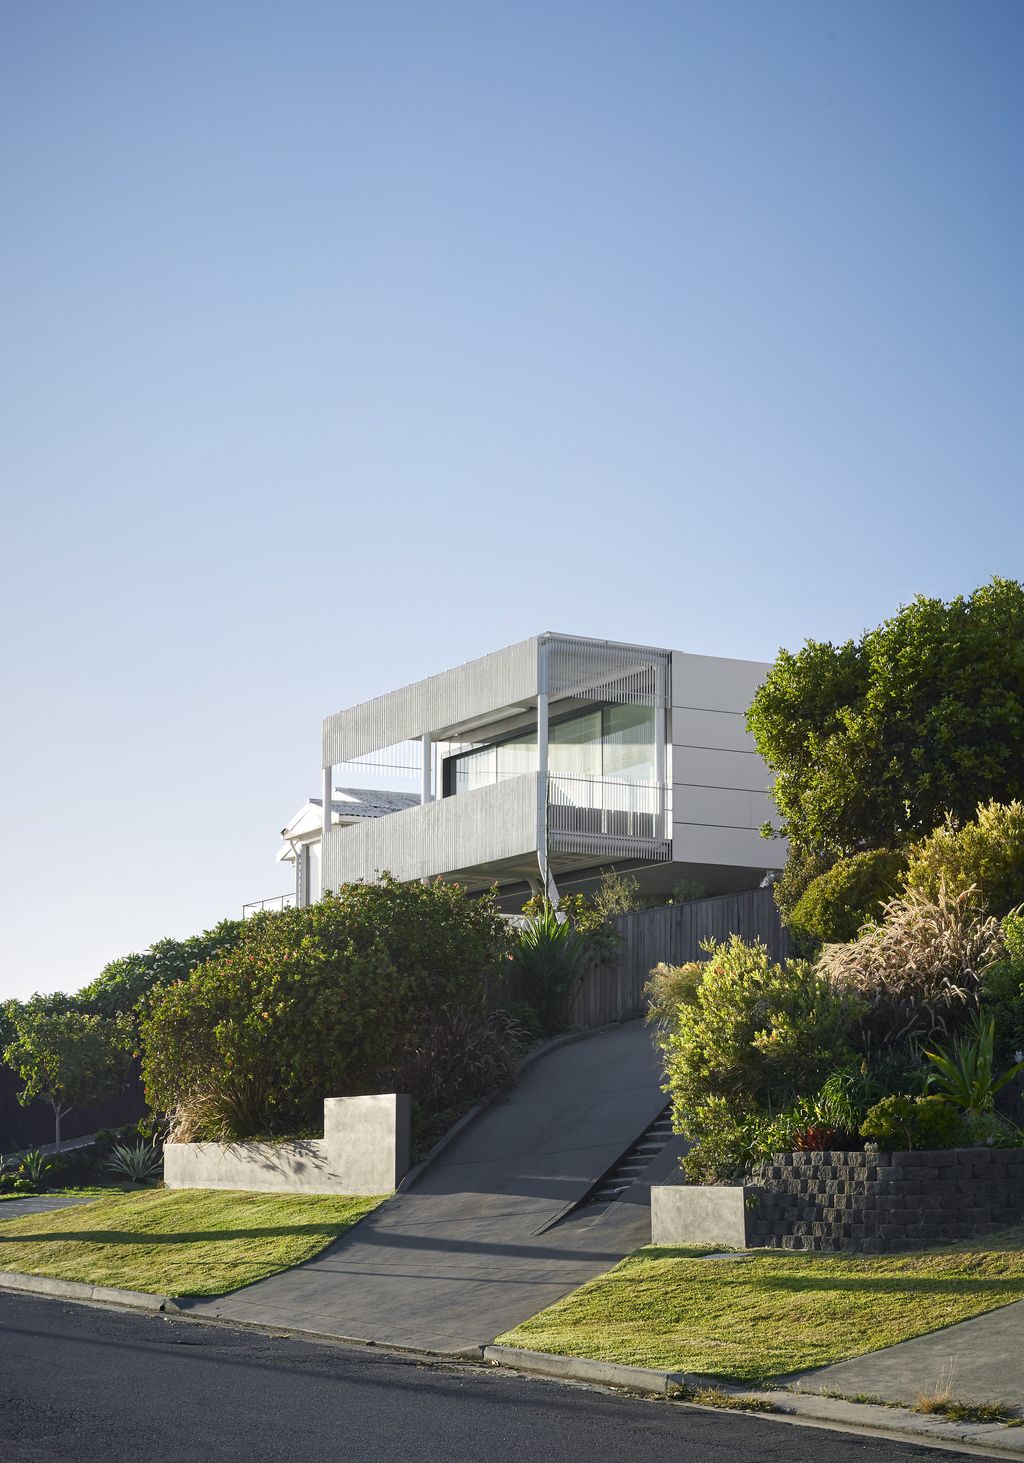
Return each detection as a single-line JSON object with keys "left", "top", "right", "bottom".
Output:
{"left": 651, "top": 1148, "right": 1024, "bottom": 1251}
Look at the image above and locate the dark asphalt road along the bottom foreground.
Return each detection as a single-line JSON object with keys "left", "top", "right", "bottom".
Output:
{"left": 0, "top": 1295, "right": 963, "bottom": 1463}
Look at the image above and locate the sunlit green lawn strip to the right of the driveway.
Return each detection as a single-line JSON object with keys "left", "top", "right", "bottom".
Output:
{"left": 499, "top": 1230, "right": 1024, "bottom": 1383}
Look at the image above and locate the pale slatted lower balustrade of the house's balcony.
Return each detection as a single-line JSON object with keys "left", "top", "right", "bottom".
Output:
{"left": 323, "top": 772, "right": 671, "bottom": 888}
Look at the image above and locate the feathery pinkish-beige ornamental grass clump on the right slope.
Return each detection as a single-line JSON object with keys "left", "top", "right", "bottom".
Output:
{"left": 819, "top": 890, "right": 1004, "bottom": 1050}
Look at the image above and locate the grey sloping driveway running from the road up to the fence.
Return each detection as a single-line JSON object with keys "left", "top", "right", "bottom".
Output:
{"left": 178, "top": 1021, "right": 677, "bottom": 1353}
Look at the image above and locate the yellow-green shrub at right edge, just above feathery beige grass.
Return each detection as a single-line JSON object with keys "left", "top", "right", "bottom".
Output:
{"left": 903, "top": 802, "right": 1024, "bottom": 914}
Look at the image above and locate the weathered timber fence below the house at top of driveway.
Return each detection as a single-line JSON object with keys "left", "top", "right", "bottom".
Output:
{"left": 569, "top": 890, "right": 790, "bottom": 1027}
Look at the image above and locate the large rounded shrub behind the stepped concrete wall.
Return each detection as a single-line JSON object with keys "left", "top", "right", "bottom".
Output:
{"left": 142, "top": 875, "right": 509, "bottom": 1140}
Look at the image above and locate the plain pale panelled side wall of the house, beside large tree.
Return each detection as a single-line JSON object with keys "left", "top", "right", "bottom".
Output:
{"left": 671, "top": 651, "right": 786, "bottom": 869}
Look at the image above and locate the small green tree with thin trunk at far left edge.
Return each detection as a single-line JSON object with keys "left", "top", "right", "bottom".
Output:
{"left": 3, "top": 996, "right": 132, "bottom": 1150}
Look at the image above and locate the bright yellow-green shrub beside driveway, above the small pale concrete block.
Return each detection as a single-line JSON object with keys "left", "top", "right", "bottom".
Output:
{"left": 655, "top": 935, "right": 862, "bottom": 1141}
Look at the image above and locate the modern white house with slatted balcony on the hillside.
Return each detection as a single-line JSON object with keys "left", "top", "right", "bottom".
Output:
{"left": 270, "top": 633, "right": 786, "bottom": 910}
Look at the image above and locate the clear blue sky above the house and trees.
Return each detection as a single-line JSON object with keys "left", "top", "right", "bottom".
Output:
{"left": 0, "top": 0, "right": 1024, "bottom": 995}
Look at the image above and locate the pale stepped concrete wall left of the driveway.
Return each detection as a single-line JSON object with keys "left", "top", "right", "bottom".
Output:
{"left": 164, "top": 1093, "right": 410, "bottom": 1194}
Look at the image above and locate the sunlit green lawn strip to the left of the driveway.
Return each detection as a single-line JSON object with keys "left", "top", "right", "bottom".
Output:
{"left": 0, "top": 1188, "right": 380, "bottom": 1295}
